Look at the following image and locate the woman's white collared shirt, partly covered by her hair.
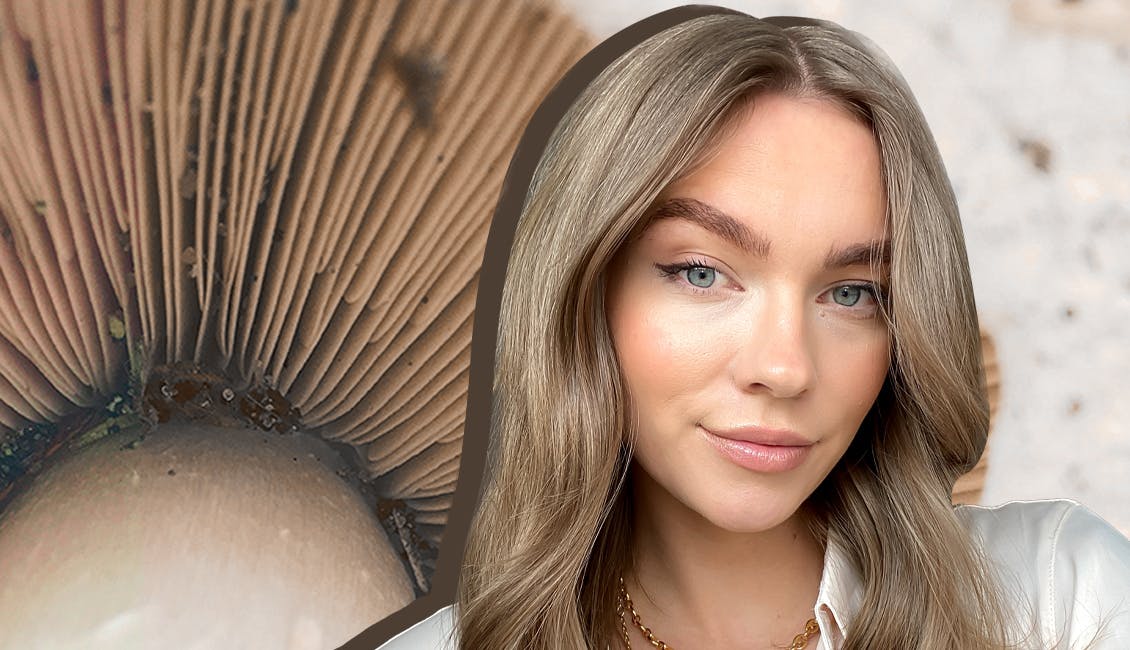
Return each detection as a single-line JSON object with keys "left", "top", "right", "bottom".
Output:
{"left": 377, "top": 500, "right": 1130, "bottom": 650}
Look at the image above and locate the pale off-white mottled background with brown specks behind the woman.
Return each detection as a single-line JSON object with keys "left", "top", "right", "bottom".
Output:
{"left": 560, "top": 0, "right": 1130, "bottom": 535}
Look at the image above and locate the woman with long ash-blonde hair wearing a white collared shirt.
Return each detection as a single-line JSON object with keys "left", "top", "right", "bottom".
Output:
{"left": 388, "top": 6, "right": 1130, "bottom": 650}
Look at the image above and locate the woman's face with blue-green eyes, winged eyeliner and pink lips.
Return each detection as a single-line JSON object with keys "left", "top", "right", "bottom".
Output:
{"left": 607, "top": 95, "right": 890, "bottom": 532}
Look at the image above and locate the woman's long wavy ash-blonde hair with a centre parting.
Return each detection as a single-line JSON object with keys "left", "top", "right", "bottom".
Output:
{"left": 458, "top": 14, "right": 1026, "bottom": 650}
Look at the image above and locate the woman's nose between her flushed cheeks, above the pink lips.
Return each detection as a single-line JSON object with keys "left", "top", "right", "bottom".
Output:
{"left": 733, "top": 296, "right": 816, "bottom": 398}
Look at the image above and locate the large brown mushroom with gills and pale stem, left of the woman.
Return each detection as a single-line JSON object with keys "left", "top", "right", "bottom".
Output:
{"left": 0, "top": 0, "right": 591, "bottom": 648}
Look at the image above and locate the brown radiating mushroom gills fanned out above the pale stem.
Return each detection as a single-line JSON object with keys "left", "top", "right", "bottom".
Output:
{"left": 0, "top": 0, "right": 592, "bottom": 592}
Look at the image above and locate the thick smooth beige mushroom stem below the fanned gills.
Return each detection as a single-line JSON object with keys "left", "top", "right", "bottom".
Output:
{"left": 0, "top": 421, "right": 415, "bottom": 649}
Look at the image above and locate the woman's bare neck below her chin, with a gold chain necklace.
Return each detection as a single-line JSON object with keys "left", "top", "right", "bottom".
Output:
{"left": 625, "top": 471, "right": 824, "bottom": 648}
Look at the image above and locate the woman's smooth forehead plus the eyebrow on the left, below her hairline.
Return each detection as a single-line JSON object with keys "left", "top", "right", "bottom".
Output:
{"left": 637, "top": 95, "right": 887, "bottom": 252}
